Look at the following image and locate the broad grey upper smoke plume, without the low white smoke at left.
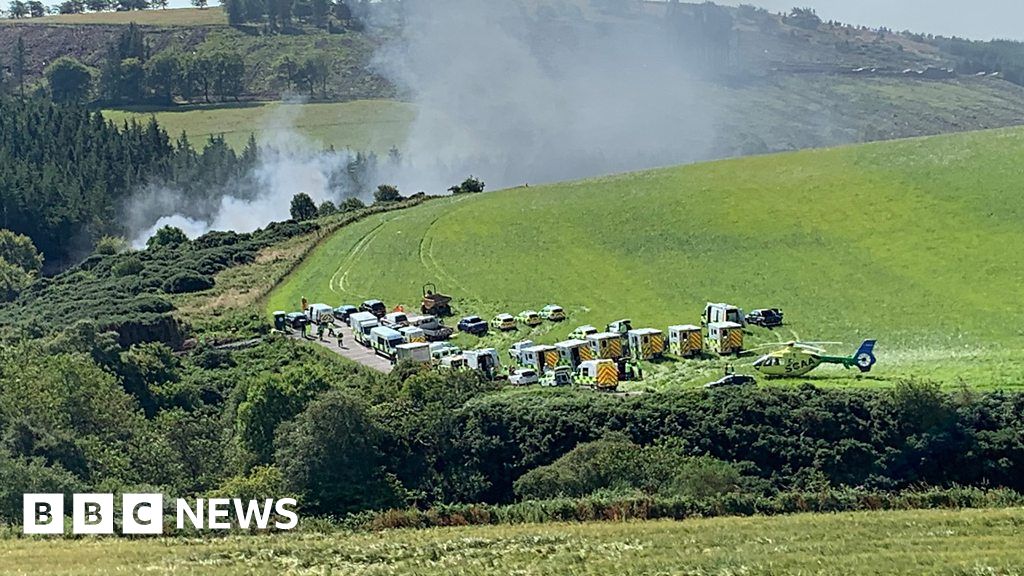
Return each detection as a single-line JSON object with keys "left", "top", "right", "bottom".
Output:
{"left": 377, "top": 0, "right": 714, "bottom": 192}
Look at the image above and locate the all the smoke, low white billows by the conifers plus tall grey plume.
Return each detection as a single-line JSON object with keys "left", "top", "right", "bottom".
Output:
{"left": 129, "top": 0, "right": 716, "bottom": 246}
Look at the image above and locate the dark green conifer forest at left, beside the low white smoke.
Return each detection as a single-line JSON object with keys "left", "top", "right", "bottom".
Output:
{"left": 0, "top": 98, "right": 256, "bottom": 268}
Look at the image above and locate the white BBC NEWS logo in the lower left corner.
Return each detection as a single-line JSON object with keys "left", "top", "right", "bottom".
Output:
{"left": 22, "top": 494, "right": 299, "bottom": 535}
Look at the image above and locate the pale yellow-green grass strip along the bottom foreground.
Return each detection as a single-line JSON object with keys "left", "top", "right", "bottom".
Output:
{"left": 6, "top": 509, "right": 1024, "bottom": 576}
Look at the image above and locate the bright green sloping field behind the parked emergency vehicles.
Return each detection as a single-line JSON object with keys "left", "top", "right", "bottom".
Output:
{"left": 266, "top": 125, "right": 1024, "bottom": 386}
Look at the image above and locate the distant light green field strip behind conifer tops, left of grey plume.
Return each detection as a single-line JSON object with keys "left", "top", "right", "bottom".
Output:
{"left": 103, "top": 100, "right": 415, "bottom": 154}
